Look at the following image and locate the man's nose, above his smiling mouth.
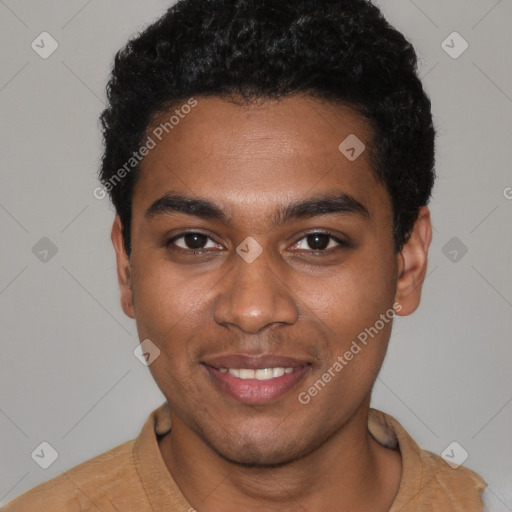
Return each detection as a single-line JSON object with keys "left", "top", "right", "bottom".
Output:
{"left": 214, "top": 246, "right": 299, "bottom": 334}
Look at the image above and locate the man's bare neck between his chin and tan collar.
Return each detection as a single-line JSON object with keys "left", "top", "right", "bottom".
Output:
{"left": 160, "top": 399, "right": 401, "bottom": 512}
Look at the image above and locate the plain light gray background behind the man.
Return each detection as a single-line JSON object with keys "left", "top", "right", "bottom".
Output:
{"left": 0, "top": 0, "right": 512, "bottom": 511}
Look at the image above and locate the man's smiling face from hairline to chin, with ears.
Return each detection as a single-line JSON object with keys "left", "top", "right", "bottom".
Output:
{"left": 112, "top": 97, "right": 428, "bottom": 464}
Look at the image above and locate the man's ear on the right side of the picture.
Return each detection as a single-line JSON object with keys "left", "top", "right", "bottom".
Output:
{"left": 395, "top": 206, "right": 432, "bottom": 316}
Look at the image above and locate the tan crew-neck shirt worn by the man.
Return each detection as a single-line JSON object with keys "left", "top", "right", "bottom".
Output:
{"left": 2, "top": 403, "right": 486, "bottom": 512}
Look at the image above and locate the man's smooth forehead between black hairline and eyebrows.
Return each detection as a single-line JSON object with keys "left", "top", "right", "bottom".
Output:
{"left": 133, "top": 97, "right": 385, "bottom": 221}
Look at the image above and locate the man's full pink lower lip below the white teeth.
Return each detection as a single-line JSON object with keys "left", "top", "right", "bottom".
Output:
{"left": 204, "top": 365, "right": 310, "bottom": 404}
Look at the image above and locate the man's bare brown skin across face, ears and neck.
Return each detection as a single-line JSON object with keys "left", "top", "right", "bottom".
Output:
{"left": 112, "top": 96, "right": 431, "bottom": 512}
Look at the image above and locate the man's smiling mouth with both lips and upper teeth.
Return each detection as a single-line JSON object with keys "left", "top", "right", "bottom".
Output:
{"left": 202, "top": 354, "right": 311, "bottom": 405}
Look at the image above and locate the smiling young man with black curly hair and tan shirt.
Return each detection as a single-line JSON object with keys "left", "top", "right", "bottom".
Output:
{"left": 5, "top": 0, "right": 486, "bottom": 512}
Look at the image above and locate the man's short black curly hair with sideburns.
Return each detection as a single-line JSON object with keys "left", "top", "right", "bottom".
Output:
{"left": 100, "top": 0, "right": 435, "bottom": 254}
